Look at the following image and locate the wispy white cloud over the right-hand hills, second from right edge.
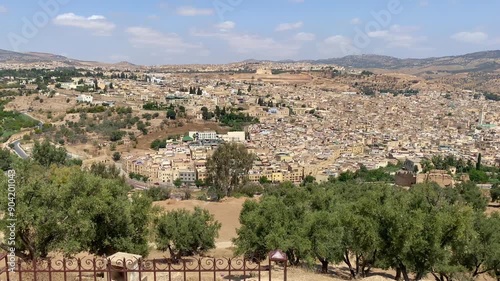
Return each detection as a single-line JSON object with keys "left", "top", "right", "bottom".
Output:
{"left": 367, "top": 25, "right": 427, "bottom": 48}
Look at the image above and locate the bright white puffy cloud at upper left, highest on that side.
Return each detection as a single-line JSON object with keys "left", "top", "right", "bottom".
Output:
{"left": 53, "top": 13, "right": 116, "bottom": 36}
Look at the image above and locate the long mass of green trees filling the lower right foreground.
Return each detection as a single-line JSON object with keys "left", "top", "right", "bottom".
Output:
{"left": 234, "top": 181, "right": 500, "bottom": 280}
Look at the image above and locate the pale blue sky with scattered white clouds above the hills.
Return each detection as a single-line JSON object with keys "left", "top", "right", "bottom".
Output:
{"left": 0, "top": 0, "right": 500, "bottom": 65}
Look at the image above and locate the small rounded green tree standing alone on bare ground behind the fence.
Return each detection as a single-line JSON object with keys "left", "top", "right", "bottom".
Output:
{"left": 155, "top": 207, "right": 221, "bottom": 261}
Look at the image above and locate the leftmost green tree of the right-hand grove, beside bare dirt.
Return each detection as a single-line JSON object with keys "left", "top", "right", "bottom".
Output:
{"left": 233, "top": 185, "right": 311, "bottom": 265}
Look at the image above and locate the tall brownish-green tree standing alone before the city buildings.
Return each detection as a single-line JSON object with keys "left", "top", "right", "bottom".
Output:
{"left": 207, "top": 143, "right": 254, "bottom": 198}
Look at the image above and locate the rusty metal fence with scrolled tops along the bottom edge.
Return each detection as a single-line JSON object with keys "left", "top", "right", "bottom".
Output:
{"left": 0, "top": 254, "right": 286, "bottom": 281}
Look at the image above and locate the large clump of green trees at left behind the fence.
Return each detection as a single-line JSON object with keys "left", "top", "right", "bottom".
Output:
{"left": 0, "top": 161, "right": 151, "bottom": 259}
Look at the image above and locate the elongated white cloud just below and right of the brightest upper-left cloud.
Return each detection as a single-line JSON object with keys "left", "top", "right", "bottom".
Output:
{"left": 126, "top": 26, "right": 204, "bottom": 53}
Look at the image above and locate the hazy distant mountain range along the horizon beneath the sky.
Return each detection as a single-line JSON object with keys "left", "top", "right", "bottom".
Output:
{"left": 0, "top": 50, "right": 500, "bottom": 73}
